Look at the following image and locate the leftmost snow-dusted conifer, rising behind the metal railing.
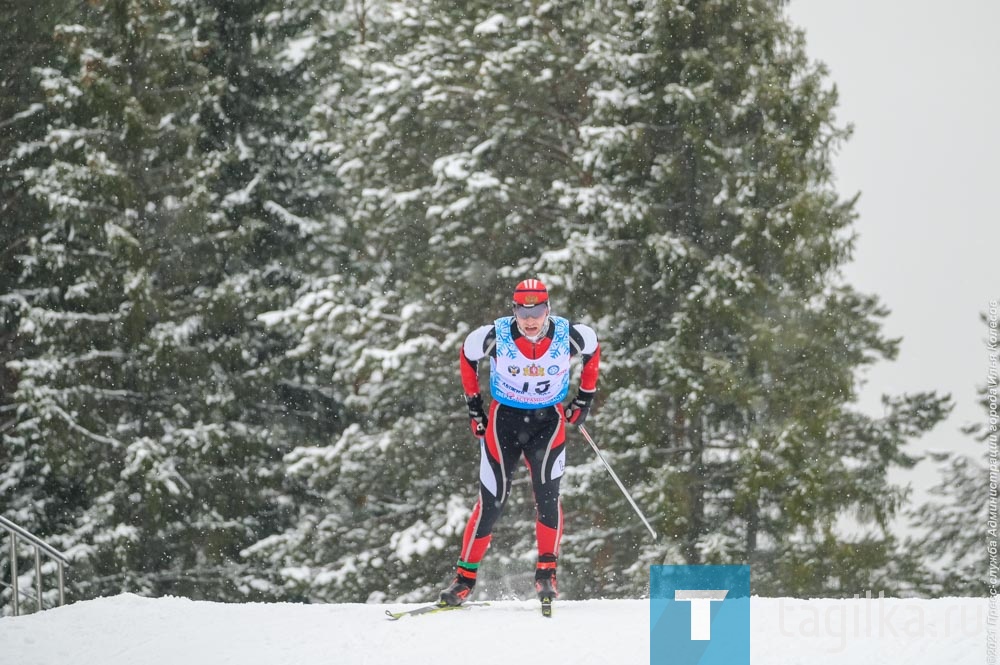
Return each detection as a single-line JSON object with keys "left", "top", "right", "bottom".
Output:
{"left": 3, "top": 3, "right": 213, "bottom": 595}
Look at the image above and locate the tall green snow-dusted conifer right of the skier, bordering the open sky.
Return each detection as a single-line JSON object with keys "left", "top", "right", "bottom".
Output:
{"left": 528, "top": 0, "right": 946, "bottom": 594}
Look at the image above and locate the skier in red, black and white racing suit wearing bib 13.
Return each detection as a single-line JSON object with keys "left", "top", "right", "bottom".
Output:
{"left": 439, "top": 279, "right": 601, "bottom": 614}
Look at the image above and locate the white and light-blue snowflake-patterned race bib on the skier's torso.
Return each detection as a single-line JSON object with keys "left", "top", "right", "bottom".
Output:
{"left": 490, "top": 316, "right": 570, "bottom": 409}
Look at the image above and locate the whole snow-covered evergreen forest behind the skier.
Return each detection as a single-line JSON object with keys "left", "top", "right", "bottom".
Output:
{"left": 0, "top": 0, "right": 986, "bottom": 602}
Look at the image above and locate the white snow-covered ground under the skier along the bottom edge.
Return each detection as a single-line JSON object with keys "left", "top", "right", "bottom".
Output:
{"left": 0, "top": 595, "right": 989, "bottom": 665}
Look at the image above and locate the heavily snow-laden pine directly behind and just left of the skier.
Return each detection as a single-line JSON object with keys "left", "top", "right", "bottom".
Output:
{"left": 244, "top": 2, "right": 616, "bottom": 600}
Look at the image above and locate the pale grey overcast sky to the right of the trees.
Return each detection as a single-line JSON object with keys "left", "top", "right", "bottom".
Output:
{"left": 788, "top": 0, "right": 1000, "bottom": 489}
